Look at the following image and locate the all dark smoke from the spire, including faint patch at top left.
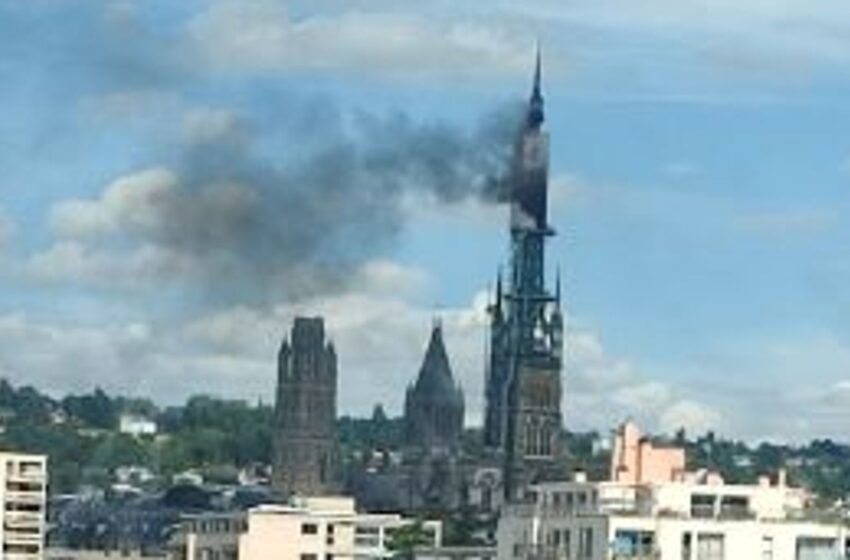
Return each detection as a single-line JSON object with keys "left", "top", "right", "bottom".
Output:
{"left": 29, "top": 2, "right": 520, "bottom": 302}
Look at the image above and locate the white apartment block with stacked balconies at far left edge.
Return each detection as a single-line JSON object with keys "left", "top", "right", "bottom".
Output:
{"left": 0, "top": 452, "right": 47, "bottom": 560}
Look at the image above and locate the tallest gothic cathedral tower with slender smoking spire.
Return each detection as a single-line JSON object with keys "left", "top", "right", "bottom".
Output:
{"left": 484, "top": 51, "right": 563, "bottom": 499}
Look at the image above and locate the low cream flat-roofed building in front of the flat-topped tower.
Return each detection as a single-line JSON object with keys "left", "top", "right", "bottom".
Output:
{"left": 173, "top": 497, "right": 442, "bottom": 560}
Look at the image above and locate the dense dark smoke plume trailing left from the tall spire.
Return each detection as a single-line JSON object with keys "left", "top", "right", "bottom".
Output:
{"left": 137, "top": 98, "right": 519, "bottom": 301}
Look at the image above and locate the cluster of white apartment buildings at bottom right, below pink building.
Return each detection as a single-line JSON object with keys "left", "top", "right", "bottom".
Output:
{"left": 497, "top": 424, "right": 850, "bottom": 560}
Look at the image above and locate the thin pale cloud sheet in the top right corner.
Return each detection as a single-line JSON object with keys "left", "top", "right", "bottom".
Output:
{"left": 502, "top": 0, "right": 850, "bottom": 69}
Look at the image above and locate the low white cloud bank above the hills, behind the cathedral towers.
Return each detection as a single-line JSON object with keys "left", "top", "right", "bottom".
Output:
{"left": 0, "top": 250, "right": 719, "bottom": 438}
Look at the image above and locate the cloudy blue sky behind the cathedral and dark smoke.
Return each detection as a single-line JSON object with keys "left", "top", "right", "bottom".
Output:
{"left": 0, "top": 0, "right": 850, "bottom": 440}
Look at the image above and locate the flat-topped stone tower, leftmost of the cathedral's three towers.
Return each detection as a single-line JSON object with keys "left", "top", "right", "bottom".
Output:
{"left": 272, "top": 317, "right": 337, "bottom": 497}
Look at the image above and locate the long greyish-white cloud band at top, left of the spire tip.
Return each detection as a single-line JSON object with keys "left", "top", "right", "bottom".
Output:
{"left": 189, "top": 0, "right": 531, "bottom": 79}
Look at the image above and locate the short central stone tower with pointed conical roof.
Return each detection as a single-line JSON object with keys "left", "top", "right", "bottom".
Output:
{"left": 404, "top": 324, "right": 464, "bottom": 454}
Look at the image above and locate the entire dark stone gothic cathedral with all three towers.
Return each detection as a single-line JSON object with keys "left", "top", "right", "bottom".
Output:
{"left": 272, "top": 53, "right": 564, "bottom": 520}
